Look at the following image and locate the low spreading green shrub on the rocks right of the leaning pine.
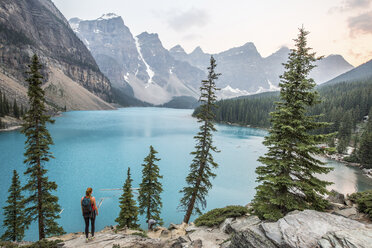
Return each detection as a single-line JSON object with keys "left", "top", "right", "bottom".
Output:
{"left": 195, "top": 206, "right": 248, "bottom": 227}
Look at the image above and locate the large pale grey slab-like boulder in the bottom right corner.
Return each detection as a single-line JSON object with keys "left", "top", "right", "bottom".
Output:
{"left": 225, "top": 210, "right": 372, "bottom": 248}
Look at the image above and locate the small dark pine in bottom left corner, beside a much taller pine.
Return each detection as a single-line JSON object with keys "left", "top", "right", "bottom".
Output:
{"left": 1, "top": 170, "right": 26, "bottom": 241}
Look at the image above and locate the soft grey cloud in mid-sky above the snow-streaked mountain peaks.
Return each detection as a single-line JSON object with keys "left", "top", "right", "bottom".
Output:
{"left": 167, "top": 8, "right": 209, "bottom": 32}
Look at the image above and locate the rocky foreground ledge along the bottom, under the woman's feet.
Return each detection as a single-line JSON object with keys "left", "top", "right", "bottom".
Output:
{"left": 8, "top": 192, "right": 372, "bottom": 248}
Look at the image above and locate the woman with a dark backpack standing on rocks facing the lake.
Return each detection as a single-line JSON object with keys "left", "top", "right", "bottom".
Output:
{"left": 80, "top": 188, "right": 98, "bottom": 242}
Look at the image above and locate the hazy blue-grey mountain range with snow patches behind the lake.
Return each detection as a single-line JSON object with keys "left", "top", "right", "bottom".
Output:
{"left": 70, "top": 13, "right": 353, "bottom": 104}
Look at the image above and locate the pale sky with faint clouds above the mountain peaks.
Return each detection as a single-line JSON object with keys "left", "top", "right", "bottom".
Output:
{"left": 52, "top": 0, "right": 372, "bottom": 66}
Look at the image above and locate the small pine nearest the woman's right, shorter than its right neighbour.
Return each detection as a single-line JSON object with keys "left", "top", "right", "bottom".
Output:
{"left": 115, "top": 167, "right": 138, "bottom": 228}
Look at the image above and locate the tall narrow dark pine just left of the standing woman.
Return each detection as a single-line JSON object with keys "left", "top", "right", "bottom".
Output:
{"left": 22, "top": 55, "right": 64, "bottom": 240}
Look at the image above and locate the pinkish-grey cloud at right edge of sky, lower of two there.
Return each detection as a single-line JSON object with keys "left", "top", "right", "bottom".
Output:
{"left": 348, "top": 11, "right": 372, "bottom": 37}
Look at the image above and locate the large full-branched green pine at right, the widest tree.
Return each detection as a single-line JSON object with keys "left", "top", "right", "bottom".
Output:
{"left": 253, "top": 28, "right": 333, "bottom": 220}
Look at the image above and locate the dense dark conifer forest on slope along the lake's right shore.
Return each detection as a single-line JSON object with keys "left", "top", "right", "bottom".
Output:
{"left": 194, "top": 78, "right": 372, "bottom": 159}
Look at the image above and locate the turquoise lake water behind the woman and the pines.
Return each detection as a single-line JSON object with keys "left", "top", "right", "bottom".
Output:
{"left": 0, "top": 108, "right": 372, "bottom": 240}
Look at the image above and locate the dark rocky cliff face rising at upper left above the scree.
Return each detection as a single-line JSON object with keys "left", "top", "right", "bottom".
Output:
{"left": 0, "top": 0, "right": 112, "bottom": 109}
